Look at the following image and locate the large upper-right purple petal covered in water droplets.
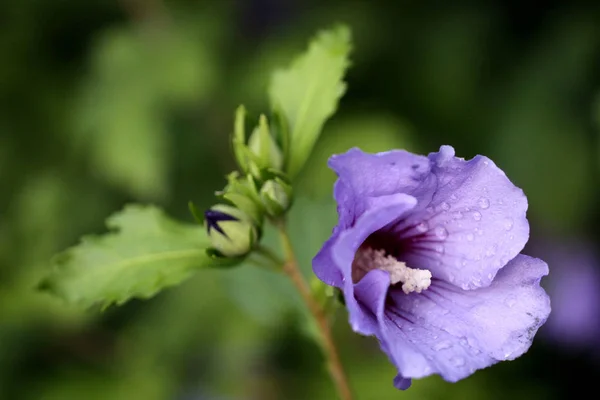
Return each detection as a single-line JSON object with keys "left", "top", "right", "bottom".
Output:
{"left": 394, "top": 146, "right": 529, "bottom": 289}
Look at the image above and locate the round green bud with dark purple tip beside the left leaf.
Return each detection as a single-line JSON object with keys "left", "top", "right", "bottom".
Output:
{"left": 204, "top": 204, "right": 258, "bottom": 257}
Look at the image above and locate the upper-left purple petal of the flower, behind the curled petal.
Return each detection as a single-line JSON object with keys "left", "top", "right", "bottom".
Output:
{"left": 328, "top": 148, "right": 435, "bottom": 229}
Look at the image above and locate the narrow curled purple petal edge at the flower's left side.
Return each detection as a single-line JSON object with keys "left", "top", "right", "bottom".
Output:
{"left": 313, "top": 193, "right": 417, "bottom": 334}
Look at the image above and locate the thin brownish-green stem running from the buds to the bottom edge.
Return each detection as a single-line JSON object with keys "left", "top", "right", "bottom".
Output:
{"left": 277, "top": 222, "right": 352, "bottom": 400}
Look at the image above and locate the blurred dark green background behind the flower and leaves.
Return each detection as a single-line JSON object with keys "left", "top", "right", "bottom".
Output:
{"left": 0, "top": 0, "right": 600, "bottom": 400}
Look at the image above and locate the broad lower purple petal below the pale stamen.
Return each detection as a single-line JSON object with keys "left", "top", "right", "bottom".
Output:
{"left": 377, "top": 255, "right": 550, "bottom": 382}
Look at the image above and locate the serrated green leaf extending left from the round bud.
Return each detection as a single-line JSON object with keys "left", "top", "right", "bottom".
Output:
{"left": 40, "top": 205, "right": 237, "bottom": 307}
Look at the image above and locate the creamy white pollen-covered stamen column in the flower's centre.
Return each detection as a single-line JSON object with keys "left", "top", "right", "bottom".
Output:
{"left": 352, "top": 247, "right": 431, "bottom": 294}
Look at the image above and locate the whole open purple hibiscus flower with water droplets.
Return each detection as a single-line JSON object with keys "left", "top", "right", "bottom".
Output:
{"left": 313, "top": 146, "right": 550, "bottom": 389}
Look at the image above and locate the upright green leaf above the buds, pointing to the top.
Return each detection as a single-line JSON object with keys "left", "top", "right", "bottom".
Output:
{"left": 269, "top": 26, "right": 351, "bottom": 177}
